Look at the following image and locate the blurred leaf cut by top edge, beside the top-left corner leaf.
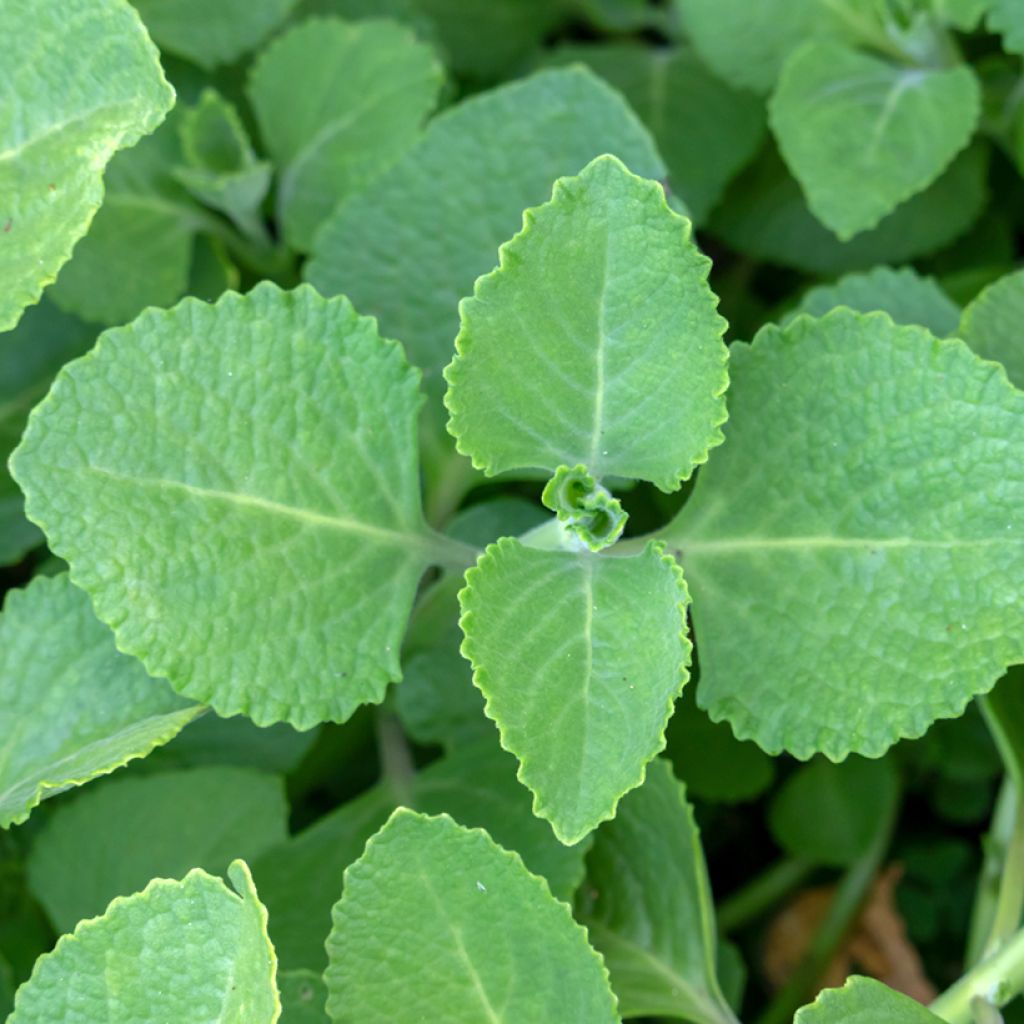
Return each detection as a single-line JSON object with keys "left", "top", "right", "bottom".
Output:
{"left": 132, "top": 0, "right": 296, "bottom": 71}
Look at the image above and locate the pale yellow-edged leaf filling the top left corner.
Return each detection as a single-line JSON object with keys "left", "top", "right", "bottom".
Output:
{"left": 0, "top": 0, "right": 174, "bottom": 331}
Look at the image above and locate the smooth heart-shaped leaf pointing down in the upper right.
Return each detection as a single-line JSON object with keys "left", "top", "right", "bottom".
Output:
{"left": 769, "top": 42, "right": 981, "bottom": 241}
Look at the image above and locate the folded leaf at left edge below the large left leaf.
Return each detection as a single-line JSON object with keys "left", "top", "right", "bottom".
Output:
{"left": 0, "top": 574, "right": 203, "bottom": 828}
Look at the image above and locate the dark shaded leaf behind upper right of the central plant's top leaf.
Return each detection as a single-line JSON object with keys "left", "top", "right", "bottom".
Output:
{"left": 551, "top": 43, "right": 765, "bottom": 224}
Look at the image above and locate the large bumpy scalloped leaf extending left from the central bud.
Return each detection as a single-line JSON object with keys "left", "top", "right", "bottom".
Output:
{"left": 11, "top": 284, "right": 433, "bottom": 729}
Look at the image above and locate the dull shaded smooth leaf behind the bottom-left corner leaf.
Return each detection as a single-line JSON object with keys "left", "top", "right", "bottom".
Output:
{"left": 29, "top": 766, "right": 288, "bottom": 932}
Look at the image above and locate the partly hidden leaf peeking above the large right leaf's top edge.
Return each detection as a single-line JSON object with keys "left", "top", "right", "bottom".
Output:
{"left": 782, "top": 266, "right": 961, "bottom": 338}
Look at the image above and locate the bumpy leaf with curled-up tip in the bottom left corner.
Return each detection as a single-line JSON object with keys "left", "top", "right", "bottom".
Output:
{"left": 8, "top": 860, "right": 281, "bottom": 1024}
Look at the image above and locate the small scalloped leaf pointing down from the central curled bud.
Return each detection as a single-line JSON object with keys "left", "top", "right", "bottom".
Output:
{"left": 459, "top": 539, "right": 690, "bottom": 844}
